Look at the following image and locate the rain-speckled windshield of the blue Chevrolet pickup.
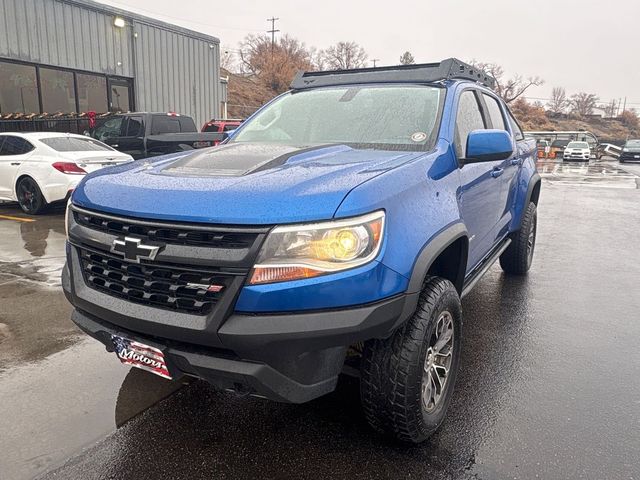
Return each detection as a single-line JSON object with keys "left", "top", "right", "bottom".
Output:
{"left": 233, "top": 85, "right": 444, "bottom": 150}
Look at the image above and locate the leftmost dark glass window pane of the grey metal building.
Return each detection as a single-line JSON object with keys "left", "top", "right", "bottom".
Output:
{"left": 0, "top": 62, "right": 40, "bottom": 114}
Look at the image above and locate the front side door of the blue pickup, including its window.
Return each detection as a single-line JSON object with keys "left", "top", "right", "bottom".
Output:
{"left": 454, "top": 88, "right": 504, "bottom": 271}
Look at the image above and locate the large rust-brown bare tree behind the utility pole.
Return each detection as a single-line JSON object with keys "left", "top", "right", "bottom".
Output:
{"left": 240, "top": 34, "right": 312, "bottom": 93}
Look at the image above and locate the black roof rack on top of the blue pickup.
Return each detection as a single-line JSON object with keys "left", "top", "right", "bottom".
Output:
{"left": 291, "top": 58, "right": 496, "bottom": 90}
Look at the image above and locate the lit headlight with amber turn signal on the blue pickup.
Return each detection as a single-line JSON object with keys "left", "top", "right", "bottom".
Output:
{"left": 249, "top": 211, "right": 384, "bottom": 285}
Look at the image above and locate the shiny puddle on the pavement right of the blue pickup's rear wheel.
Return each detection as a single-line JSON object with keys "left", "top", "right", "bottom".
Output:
{"left": 537, "top": 161, "right": 640, "bottom": 189}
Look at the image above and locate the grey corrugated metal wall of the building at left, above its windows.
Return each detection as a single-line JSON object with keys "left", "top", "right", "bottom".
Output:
{"left": 0, "top": 0, "right": 220, "bottom": 126}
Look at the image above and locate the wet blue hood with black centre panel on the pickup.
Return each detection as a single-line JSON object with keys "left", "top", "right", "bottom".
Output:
{"left": 72, "top": 143, "right": 423, "bottom": 225}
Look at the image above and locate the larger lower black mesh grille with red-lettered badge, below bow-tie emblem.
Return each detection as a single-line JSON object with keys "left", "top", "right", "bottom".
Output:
{"left": 78, "top": 248, "right": 240, "bottom": 315}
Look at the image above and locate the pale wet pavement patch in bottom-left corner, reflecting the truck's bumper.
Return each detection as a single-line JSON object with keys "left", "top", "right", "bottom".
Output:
{"left": 0, "top": 338, "right": 188, "bottom": 480}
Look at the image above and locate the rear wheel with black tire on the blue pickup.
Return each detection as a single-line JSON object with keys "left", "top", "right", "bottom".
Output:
{"left": 500, "top": 202, "right": 538, "bottom": 275}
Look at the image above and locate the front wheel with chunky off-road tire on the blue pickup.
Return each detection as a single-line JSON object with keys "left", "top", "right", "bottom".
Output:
{"left": 360, "top": 277, "right": 462, "bottom": 443}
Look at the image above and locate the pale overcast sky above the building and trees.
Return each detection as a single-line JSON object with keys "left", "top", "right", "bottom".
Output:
{"left": 99, "top": 0, "right": 640, "bottom": 110}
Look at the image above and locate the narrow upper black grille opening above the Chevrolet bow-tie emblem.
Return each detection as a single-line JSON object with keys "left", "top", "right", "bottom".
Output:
{"left": 73, "top": 210, "right": 256, "bottom": 248}
